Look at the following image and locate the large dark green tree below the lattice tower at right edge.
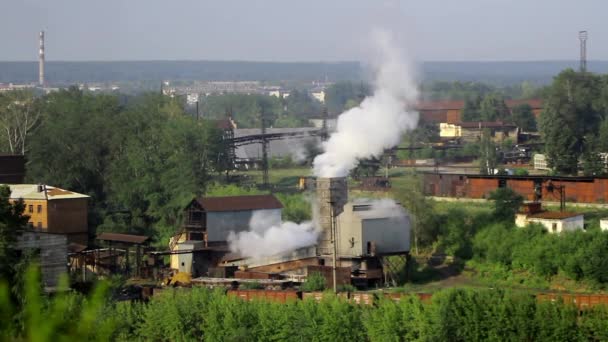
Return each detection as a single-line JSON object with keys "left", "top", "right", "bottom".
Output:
{"left": 540, "top": 69, "right": 602, "bottom": 174}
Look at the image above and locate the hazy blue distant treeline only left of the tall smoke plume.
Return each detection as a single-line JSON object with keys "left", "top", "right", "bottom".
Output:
{"left": 0, "top": 61, "right": 361, "bottom": 84}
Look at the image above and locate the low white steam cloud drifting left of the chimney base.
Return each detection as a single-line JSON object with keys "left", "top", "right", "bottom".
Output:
{"left": 228, "top": 211, "right": 319, "bottom": 258}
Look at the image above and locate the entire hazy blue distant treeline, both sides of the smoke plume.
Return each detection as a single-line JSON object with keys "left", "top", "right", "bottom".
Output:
{"left": 0, "top": 60, "right": 608, "bottom": 85}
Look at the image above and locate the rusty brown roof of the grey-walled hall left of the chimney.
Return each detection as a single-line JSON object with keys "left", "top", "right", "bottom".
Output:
{"left": 196, "top": 195, "right": 283, "bottom": 212}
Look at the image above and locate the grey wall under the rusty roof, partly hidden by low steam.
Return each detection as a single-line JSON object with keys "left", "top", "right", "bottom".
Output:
{"left": 207, "top": 209, "right": 281, "bottom": 242}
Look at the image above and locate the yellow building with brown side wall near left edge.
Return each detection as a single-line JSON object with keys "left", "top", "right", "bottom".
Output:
{"left": 8, "top": 184, "right": 89, "bottom": 245}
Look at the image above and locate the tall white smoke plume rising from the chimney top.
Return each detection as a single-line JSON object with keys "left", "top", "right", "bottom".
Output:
{"left": 313, "top": 31, "right": 418, "bottom": 177}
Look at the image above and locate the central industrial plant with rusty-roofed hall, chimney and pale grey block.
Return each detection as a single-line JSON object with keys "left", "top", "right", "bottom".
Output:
{"left": 170, "top": 178, "right": 411, "bottom": 285}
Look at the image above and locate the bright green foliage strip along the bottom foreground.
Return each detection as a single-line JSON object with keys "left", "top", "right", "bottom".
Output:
{"left": 0, "top": 271, "right": 608, "bottom": 341}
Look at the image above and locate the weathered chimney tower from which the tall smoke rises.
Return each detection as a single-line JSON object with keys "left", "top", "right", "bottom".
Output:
{"left": 316, "top": 177, "right": 348, "bottom": 256}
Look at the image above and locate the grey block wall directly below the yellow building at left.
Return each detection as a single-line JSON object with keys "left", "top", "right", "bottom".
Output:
{"left": 16, "top": 231, "right": 68, "bottom": 288}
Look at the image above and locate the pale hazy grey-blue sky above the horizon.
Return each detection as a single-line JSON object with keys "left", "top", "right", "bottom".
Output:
{"left": 0, "top": 0, "right": 608, "bottom": 61}
